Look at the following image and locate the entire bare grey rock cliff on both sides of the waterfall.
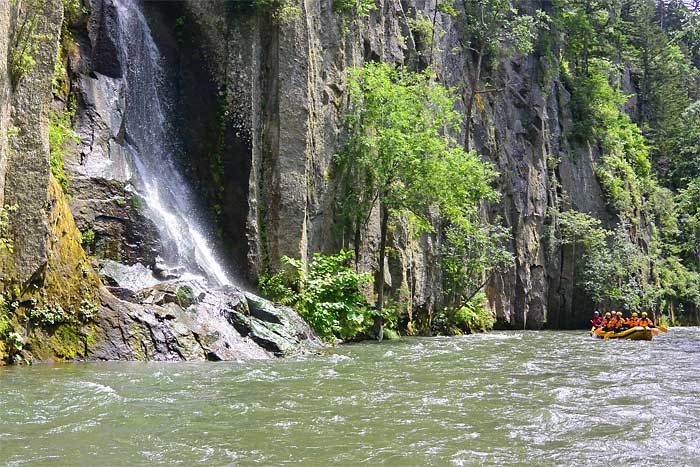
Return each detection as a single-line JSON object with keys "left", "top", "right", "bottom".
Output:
{"left": 0, "top": 0, "right": 624, "bottom": 366}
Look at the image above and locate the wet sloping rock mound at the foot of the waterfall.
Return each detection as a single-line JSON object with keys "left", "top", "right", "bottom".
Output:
{"left": 89, "top": 280, "right": 322, "bottom": 361}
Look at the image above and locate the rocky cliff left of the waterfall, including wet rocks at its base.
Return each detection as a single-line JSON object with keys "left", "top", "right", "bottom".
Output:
{"left": 0, "top": 0, "right": 320, "bottom": 364}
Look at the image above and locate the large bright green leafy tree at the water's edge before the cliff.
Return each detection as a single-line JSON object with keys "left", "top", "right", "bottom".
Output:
{"left": 338, "top": 63, "right": 497, "bottom": 338}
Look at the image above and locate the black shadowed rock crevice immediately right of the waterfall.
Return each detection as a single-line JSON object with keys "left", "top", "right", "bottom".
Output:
{"left": 144, "top": 1, "right": 252, "bottom": 281}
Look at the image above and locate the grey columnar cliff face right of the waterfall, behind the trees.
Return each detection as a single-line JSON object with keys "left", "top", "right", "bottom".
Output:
{"left": 176, "top": 0, "right": 605, "bottom": 328}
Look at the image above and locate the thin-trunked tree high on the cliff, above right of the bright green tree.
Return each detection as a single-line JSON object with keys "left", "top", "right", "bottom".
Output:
{"left": 460, "top": 0, "right": 546, "bottom": 151}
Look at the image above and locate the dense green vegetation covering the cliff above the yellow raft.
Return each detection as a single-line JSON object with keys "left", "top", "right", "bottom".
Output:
{"left": 550, "top": 0, "right": 700, "bottom": 321}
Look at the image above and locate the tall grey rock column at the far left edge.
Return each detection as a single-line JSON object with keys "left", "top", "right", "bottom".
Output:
{"left": 0, "top": 0, "right": 63, "bottom": 282}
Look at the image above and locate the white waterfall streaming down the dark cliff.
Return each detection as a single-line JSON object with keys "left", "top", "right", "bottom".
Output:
{"left": 115, "top": 0, "right": 231, "bottom": 285}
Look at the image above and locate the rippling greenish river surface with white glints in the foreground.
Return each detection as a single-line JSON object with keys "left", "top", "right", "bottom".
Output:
{"left": 0, "top": 328, "right": 700, "bottom": 467}
